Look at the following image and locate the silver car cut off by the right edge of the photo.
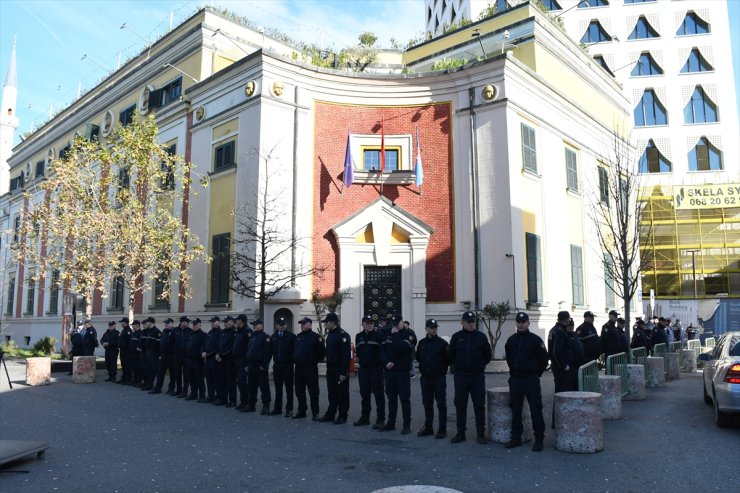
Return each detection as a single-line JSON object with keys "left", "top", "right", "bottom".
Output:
{"left": 699, "top": 332, "right": 740, "bottom": 427}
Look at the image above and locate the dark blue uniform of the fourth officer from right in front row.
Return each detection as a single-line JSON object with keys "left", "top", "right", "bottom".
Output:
{"left": 381, "top": 329, "right": 416, "bottom": 429}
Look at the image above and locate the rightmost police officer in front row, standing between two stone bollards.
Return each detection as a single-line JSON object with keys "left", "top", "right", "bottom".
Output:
{"left": 505, "top": 312, "right": 548, "bottom": 452}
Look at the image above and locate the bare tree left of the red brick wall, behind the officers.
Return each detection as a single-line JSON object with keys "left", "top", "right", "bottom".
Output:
{"left": 230, "top": 145, "right": 318, "bottom": 318}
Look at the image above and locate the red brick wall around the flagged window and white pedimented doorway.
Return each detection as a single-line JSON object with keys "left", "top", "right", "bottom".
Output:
{"left": 313, "top": 102, "right": 455, "bottom": 302}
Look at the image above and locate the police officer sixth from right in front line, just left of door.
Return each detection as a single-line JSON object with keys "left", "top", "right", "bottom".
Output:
{"left": 318, "top": 313, "right": 352, "bottom": 425}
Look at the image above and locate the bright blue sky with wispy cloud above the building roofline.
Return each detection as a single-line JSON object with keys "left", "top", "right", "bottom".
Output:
{"left": 0, "top": 0, "right": 740, "bottom": 143}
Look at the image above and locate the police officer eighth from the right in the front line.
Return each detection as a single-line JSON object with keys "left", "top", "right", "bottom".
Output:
{"left": 270, "top": 317, "right": 295, "bottom": 418}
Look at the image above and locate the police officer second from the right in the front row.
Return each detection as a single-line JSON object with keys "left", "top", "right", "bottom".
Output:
{"left": 450, "top": 312, "right": 491, "bottom": 445}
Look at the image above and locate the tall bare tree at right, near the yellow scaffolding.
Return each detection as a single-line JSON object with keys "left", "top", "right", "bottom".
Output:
{"left": 589, "top": 129, "right": 653, "bottom": 338}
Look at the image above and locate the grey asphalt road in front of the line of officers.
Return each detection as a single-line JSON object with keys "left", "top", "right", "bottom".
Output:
{"left": 0, "top": 361, "right": 740, "bottom": 493}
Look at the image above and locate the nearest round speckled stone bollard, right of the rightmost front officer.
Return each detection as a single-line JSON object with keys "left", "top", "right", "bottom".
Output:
{"left": 553, "top": 392, "right": 604, "bottom": 454}
